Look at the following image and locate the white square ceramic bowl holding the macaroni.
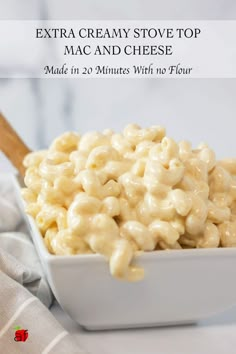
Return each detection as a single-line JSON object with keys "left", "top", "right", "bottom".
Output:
{"left": 13, "top": 176, "right": 236, "bottom": 330}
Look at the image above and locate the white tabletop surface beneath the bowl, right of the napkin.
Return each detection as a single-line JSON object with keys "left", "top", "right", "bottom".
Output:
{"left": 51, "top": 304, "right": 236, "bottom": 354}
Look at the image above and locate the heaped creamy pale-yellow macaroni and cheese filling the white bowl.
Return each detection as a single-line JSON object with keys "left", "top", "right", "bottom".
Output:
{"left": 22, "top": 124, "right": 236, "bottom": 281}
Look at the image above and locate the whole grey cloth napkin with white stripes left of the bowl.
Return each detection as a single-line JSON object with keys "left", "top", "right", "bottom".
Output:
{"left": 0, "top": 176, "right": 85, "bottom": 354}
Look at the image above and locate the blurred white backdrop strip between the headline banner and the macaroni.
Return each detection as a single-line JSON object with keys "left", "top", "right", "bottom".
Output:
{"left": 0, "top": 79, "right": 236, "bottom": 158}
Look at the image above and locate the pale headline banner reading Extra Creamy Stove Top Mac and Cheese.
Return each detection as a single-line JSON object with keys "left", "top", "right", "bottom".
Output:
{"left": 0, "top": 21, "right": 236, "bottom": 78}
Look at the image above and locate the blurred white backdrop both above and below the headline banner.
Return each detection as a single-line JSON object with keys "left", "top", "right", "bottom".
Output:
{"left": 0, "top": 0, "right": 236, "bottom": 158}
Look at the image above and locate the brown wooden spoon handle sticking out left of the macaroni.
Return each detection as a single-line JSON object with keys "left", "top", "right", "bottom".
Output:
{"left": 0, "top": 112, "right": 30, "bottom": 177}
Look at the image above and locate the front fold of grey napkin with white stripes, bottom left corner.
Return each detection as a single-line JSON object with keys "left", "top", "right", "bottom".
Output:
{"left": 0, "top": 271, "right": 85, "bottom": 354}
